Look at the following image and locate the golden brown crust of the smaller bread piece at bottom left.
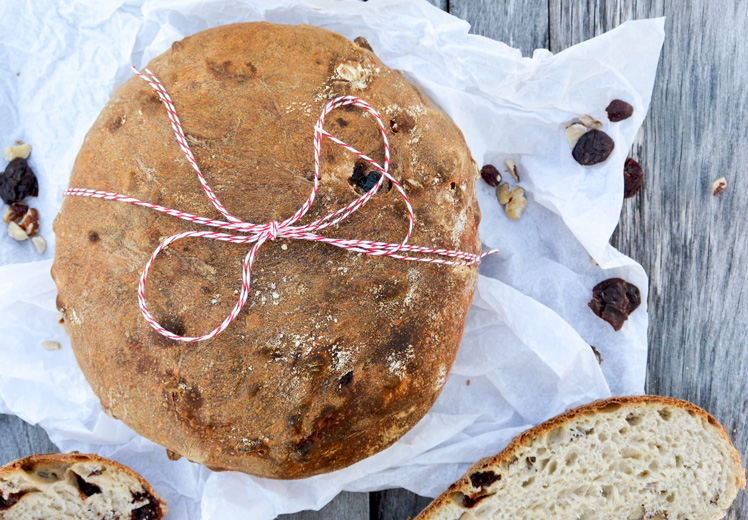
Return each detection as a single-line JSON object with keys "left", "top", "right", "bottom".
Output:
{"left": 0, "top": 452, "right": 167, "bottom": 518}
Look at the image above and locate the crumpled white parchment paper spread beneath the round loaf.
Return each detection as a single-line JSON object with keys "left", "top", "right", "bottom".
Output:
{"left": 0, "top": 0, "right": 664, "bottom": 520}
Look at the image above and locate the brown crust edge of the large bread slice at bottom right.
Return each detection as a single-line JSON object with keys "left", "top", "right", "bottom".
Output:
{"left": 414, "top": 395, "right": 746, "bottom": 520}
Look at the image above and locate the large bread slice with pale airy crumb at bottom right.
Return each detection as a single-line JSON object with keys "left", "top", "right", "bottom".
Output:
{"left": 416, "top": 396, "right": 745, "bottom": 520}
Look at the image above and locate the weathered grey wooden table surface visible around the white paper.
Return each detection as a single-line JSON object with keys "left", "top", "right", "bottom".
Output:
{"left": 0, "top": 0, "right": 748, "bottom": 520}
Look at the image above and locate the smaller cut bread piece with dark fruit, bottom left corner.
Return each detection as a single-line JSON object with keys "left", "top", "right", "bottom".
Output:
{"left": 0, "top": 453, "right": 166, "bottom": 520}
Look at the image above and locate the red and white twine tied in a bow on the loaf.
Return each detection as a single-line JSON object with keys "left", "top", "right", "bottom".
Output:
{"left": 64, "top": 67, "right": 497, "bottom": 342}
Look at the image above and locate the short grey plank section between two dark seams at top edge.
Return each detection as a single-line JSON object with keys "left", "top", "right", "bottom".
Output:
{"left": 449, "top": 0, "right": 550, "bottom": 56}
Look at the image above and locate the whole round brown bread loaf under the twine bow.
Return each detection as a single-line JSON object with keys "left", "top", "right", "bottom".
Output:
{"left": 53, "top": 23, "right": 480, "bottom": 478}
